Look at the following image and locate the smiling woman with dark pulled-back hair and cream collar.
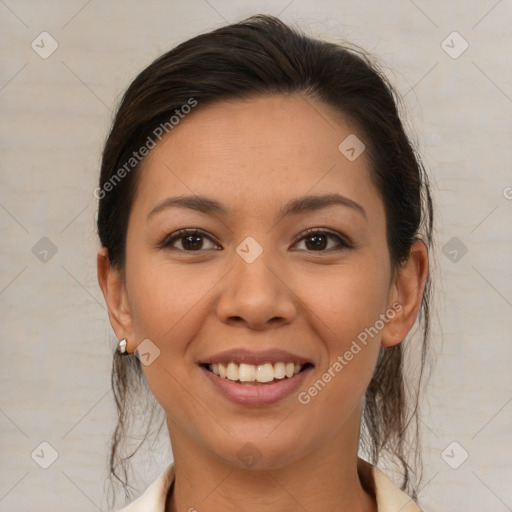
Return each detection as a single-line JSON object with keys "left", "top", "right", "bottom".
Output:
{"left": 96, "top": 16, "right": 432, "bottom": 512}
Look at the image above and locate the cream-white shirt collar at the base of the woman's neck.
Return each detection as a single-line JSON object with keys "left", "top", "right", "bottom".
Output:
{"left": 119, "top": 459, "right": 421, "bottom": 512}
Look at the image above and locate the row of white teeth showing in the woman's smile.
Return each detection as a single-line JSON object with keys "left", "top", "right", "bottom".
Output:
{"left": 209, "top": 361, "right": 303, "bottom": 383}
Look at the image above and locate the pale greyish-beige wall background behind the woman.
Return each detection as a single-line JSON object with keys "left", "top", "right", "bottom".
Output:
{"left": 0, "top": 0, "right": 512, "bottom": 512}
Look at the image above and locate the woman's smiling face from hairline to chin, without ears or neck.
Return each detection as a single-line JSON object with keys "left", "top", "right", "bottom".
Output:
{"left": 112, "top": 96, "right": 404, "bottom": 468}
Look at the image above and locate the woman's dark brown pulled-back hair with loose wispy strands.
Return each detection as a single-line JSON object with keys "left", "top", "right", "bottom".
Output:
{"left": 97, "top": 15, "right": 433, "bottom": 508}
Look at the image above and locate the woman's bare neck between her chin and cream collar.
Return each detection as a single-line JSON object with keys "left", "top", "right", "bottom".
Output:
{"left": 166, "top": 418, "right": 377, "bottom": 512}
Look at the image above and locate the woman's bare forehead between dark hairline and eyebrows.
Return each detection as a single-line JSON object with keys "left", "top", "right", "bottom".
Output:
{"left": 132, "top": 95, "right": 382, "bottom": 223}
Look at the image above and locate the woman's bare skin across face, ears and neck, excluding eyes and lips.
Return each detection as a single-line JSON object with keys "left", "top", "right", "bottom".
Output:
{"left": 98, "top": 95, "right": 428, "bottom": 512}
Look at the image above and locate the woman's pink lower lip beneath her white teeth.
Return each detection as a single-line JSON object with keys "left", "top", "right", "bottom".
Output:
{"left": 201, "top": 366, "right": 313, "bottom": 407}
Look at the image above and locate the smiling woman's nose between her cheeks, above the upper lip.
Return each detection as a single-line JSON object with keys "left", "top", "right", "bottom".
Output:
{"left": 216, "top": 245, "right": 297, "bottom": 330}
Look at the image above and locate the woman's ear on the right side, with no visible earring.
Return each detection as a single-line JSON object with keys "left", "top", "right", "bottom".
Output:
{"left": 381, "top": 240, "right": 428, "bottom": 347}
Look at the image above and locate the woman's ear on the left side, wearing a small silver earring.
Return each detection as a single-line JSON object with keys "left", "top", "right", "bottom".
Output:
{"left": 96, "top": 247, "right": 135, "bottom": 352}
